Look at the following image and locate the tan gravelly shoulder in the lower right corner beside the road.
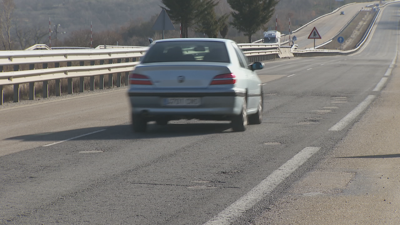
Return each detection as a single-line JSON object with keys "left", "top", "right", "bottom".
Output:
{"left": 255, "top": 58, "right": 400, "bottom": 225}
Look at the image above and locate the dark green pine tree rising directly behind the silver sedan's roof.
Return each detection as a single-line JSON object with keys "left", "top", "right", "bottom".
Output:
{"left": 162, "top": 0, "right": 217, "bottom": 38}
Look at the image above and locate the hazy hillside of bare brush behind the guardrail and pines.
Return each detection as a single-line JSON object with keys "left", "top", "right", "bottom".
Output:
{"left": 0, "top": 0, "right": 378, "bottom": 50}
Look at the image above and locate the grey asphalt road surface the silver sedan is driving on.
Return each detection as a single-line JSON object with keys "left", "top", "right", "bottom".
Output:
{"left": 0, "top": 4, "right": 400, "bottom": 225}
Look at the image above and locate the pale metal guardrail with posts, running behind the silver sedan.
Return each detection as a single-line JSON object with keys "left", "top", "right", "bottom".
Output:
{"left": 0, "top": 44, "right": 279, "bottom": 105}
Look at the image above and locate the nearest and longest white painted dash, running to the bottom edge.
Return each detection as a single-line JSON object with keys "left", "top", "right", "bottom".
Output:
{"left": 204, "top": 147, "right": 321, "bottom": 225}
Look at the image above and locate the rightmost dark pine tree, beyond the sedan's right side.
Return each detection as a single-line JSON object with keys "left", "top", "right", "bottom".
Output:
{"left": 228, "top": 0, "right": 279, "bottom": 42}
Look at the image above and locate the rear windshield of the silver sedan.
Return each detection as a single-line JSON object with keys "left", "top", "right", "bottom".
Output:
{"left": 142, "top": 41, "right": 230, "bottom": 63}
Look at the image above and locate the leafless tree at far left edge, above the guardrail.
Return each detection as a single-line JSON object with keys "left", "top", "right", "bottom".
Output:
{"left": 0, "top": 0, "right": 15, "bottom": 50}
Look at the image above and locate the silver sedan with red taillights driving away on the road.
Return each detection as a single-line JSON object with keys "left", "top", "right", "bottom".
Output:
{"left": 128, "top": 38, "right": 263, "bottom": 132}
